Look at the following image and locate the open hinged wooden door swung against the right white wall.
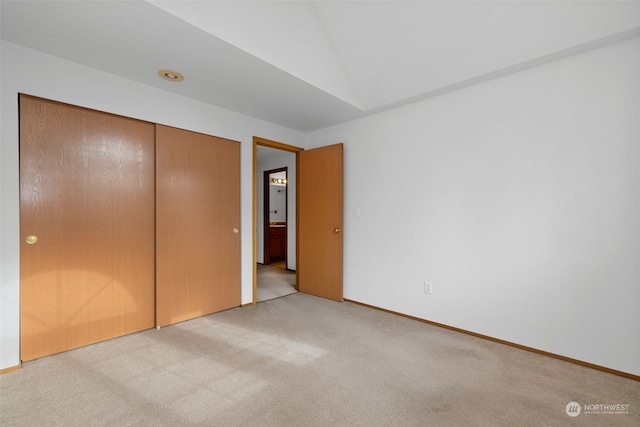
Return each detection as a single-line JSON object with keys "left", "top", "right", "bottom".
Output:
{"left": 297, "top": 144, "right": 343, "bottom": 301}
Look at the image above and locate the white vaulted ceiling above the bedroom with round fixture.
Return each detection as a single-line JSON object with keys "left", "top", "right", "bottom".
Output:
{"left": 0, "top": 0, "right": 640, "bottom": 132}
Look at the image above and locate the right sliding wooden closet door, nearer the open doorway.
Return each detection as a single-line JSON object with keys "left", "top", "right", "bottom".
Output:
{"left": 156, "top": 125, "right": 240, "bottom": 326}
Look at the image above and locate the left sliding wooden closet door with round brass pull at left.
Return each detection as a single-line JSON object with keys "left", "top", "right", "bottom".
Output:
{"left": 20, "top": 95, "right": 155, "bottom": 361}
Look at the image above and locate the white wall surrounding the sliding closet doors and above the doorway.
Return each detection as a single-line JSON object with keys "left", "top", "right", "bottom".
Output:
{"left": 0, "top": 41, "right": 304, "bottom": 369}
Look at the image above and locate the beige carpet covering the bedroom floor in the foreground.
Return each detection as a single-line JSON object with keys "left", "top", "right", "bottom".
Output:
{"left": 0, "top": 293, "right": 640, "bottom": 427}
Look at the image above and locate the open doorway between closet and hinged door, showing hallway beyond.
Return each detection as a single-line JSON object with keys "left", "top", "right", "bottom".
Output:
{"left": 254, "top": 138, "right": 301, "bottom": 302}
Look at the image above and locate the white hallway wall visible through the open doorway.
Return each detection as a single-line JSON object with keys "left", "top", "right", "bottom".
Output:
{"left": 256, "top": 151, "right": 296, "bottom": 270}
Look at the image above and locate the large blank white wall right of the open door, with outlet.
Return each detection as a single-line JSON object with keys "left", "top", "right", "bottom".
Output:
{"left": 307, "top": 39, "right": 640, "bottom": 375}
